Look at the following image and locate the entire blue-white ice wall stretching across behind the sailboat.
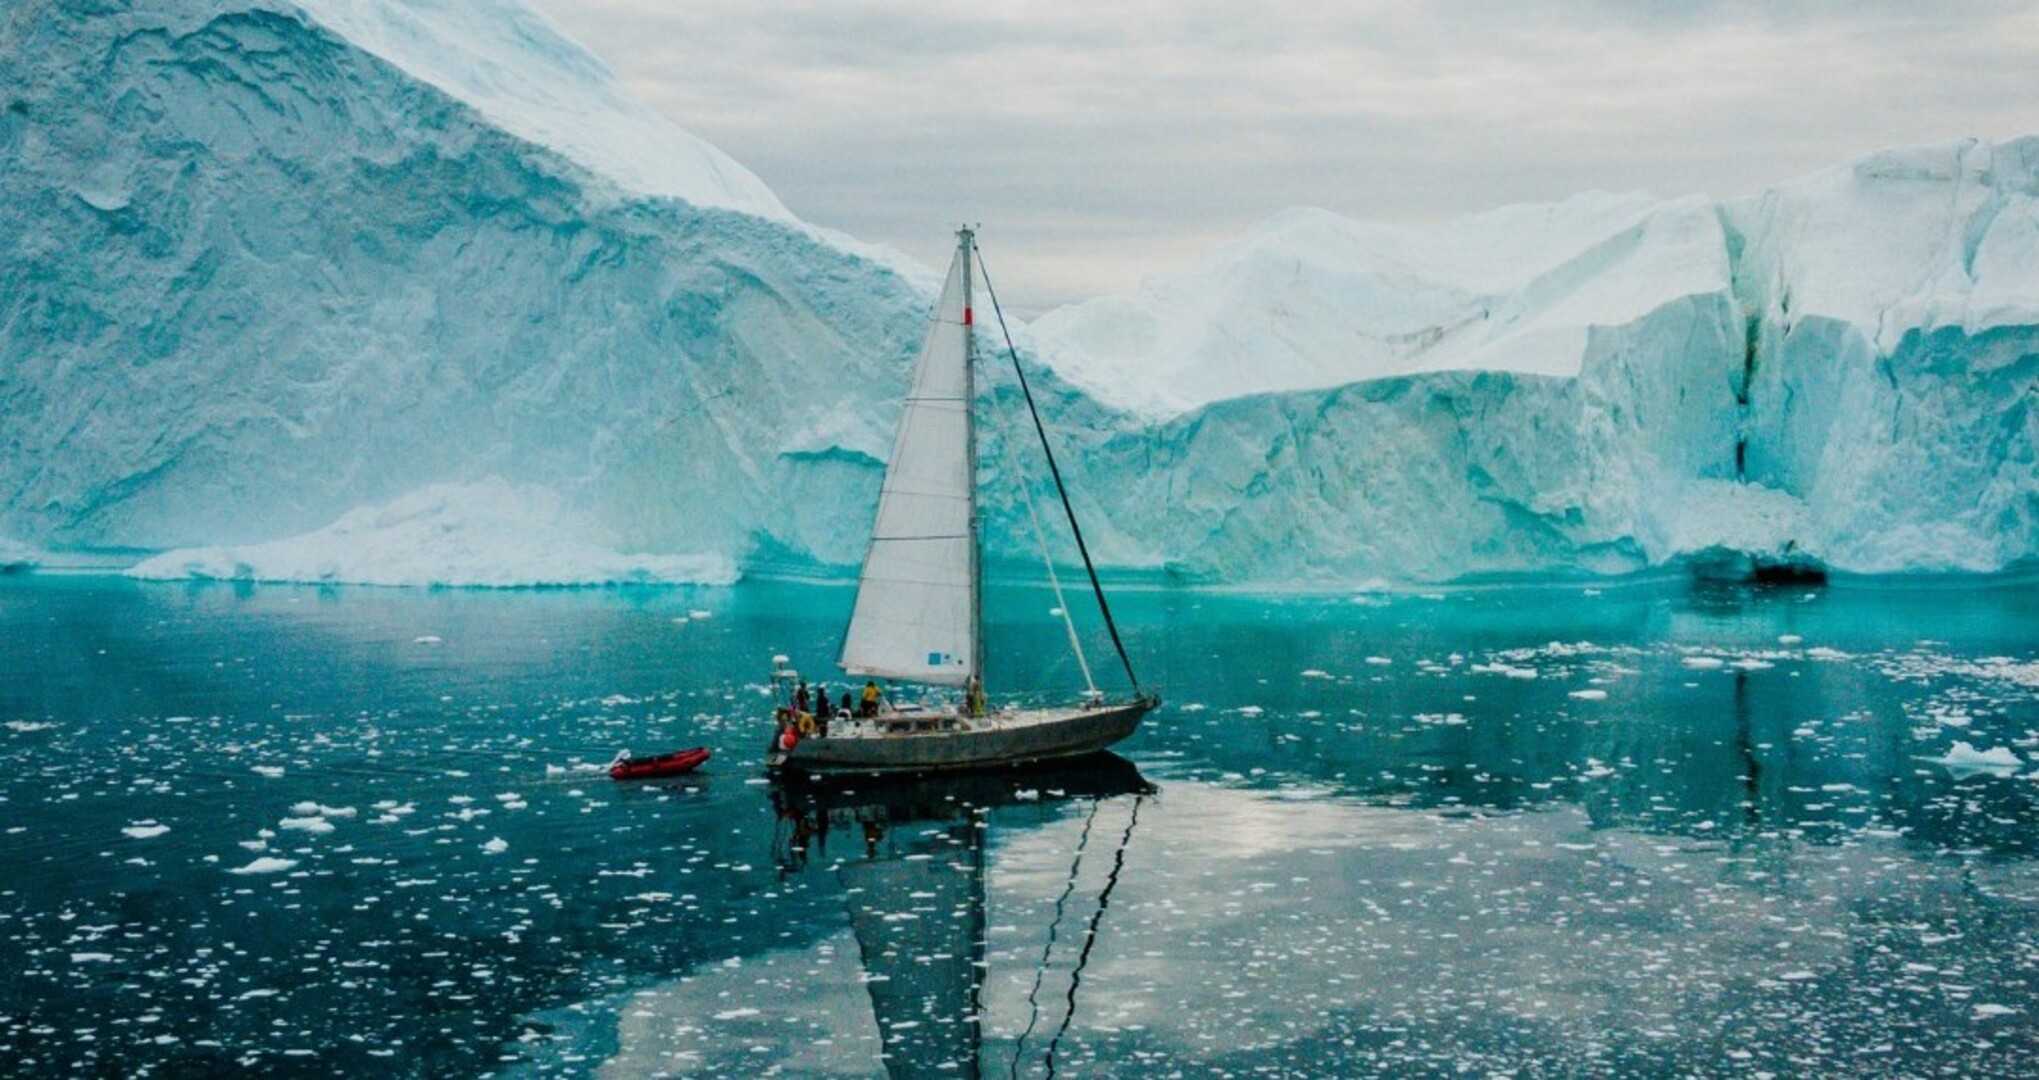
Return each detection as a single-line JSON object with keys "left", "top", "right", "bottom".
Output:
{"left": 0, "top": 0, "right": 2039, "bottom": 587}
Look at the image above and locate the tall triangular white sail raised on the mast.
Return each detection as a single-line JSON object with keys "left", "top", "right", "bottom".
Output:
{"left": 842, "top": 230, "right": 977, "bottom": 687}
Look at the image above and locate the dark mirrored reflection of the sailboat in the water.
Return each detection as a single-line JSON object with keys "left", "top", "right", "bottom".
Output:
{"left": 773, "top": 754, "right": 1154, "bottom": 1078}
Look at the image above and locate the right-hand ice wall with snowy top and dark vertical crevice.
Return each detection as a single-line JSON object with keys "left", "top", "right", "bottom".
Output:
{"left": 1034, "top": 139, "right": 2039, "bottom": 583}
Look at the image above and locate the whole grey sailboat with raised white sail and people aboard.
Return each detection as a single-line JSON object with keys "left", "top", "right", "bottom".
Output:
{"left": 765, "top": 228, "right": 1160, "bottom": 772}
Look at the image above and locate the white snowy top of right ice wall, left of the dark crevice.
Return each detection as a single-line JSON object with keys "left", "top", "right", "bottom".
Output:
{"left": 1034, "top": 194, "right": 1729, "bottom": 418}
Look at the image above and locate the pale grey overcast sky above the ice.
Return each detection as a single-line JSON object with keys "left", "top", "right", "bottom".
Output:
{"left": 532, "top": 0, "right": 2039, "bottom": 314}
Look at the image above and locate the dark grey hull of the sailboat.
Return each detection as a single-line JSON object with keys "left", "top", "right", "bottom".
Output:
{"left": 765, "top": 697, "right": 1160, "bottom": 774}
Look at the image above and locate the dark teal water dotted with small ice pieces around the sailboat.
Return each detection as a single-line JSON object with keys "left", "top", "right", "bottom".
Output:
{"left": 0, "top": 577, "right": 2039, "bottom": 1076}
